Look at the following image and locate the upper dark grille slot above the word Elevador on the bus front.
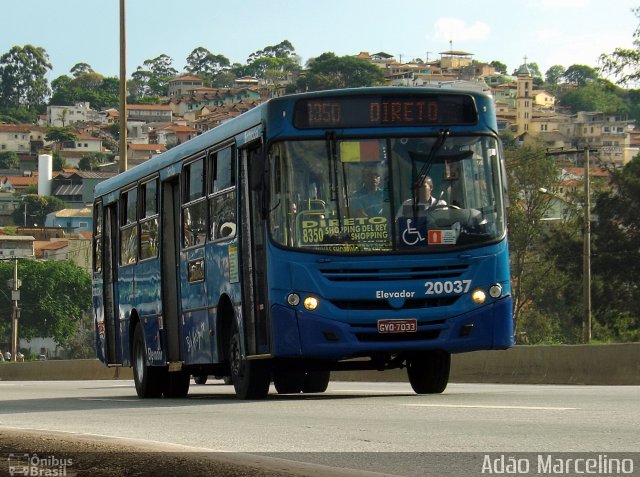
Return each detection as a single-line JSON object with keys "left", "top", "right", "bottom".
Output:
{"left": 320, "top": 264, "right": 469, "bottom": 282}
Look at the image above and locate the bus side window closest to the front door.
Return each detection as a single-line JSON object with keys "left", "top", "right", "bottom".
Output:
{"left": 209, "top": 147, "right": 236, "bottom": 240}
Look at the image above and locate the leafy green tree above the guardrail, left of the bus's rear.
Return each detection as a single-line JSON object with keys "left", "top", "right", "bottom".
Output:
{"left": 0, "top": 260, "right": 91, "bottom": 347}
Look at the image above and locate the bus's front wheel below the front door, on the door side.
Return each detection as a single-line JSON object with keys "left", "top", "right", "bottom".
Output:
{"left": 229, "top": 325, "right": 271, "bottom": 399}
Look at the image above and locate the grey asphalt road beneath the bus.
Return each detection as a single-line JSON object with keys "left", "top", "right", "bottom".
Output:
{"left": 0, "top": 381, "right": 640, "bottom": 476}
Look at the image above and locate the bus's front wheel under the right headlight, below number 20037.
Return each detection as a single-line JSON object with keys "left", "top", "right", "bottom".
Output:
{"left": 407, "top": 351, "right": 451, "bottom": 394}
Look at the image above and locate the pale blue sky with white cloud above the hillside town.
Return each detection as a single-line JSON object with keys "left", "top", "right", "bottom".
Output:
{"left": 0, "top": 0, "right": 640, "bottom": 81}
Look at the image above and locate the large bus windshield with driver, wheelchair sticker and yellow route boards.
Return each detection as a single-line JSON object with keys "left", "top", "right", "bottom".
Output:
{"left": 269, "top": 133, "right": 505, "bottom": 254}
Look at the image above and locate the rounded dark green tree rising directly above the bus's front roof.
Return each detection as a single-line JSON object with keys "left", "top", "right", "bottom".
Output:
{"left": 298, "top": 53, "right": 384, "bottom": 91}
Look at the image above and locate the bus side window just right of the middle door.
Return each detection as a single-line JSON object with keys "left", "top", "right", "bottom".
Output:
{"left": 182, "top": 158, "right": 207, "bottom": 247}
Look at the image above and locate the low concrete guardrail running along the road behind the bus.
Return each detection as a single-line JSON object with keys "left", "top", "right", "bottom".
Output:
{"left": 0, "top": 343, "right": 640, "bottom": 385}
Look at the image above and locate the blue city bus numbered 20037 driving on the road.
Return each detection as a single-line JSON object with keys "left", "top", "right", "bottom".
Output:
{"left": 93, "top": 87, "right": 513, "bottom": 399}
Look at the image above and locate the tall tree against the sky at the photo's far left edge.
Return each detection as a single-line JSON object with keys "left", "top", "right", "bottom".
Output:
{"left": 0, "top": 45, "right": 51, "bottom": 109}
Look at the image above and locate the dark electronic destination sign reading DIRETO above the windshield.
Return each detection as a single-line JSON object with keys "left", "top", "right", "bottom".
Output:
{"left": 293, "top": 94, "right": 478, "bottom": 129}
